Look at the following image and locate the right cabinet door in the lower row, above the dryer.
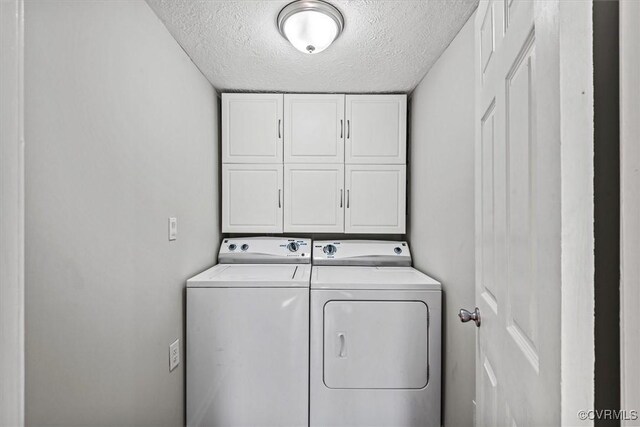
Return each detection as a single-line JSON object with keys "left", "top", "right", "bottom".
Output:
{"left": 345, "top": 165, "right": 406, "bottom": 234}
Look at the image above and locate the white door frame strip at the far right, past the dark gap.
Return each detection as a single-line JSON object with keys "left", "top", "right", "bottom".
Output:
{"left": 619, "top": 1, "right": 640, "bottom": 426}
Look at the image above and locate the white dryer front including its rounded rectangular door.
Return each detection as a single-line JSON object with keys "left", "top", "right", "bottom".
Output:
{"left": 309, "top": 288, "right": 442, "bottom": 427}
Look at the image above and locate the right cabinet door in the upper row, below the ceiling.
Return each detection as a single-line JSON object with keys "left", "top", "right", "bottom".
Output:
{"left": 345, "top": 95, "right": 407, "bottom": 164}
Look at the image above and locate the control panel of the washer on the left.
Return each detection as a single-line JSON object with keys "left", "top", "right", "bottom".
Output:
{"left": 218, "top": 237, "right": 311, "bottom": 264}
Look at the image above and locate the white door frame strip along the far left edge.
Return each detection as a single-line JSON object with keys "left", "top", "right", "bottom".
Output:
{"left": 0, "top": 0, "right": 25, "bottom": 426}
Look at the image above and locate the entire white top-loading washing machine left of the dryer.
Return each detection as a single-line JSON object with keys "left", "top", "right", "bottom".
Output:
{"left": 186, "top": 238, "right": 311, "bottom": 427}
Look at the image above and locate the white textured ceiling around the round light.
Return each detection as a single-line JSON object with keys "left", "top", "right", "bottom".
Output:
{"left": 147, "top": 0, "right": 478, "bottom": 93}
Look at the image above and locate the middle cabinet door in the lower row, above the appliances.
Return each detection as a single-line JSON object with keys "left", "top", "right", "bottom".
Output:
{"left": 284, "top": 164, "right": 345, "bottom": 233}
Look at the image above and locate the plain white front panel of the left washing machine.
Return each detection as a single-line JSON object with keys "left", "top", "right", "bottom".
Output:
{"left": 186, "top": 288, "right": 309, "bottom": 427}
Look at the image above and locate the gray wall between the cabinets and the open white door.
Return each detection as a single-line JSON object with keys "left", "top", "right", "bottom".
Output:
{"left": 408, "top": 16, "right": 475, "bottom": 426}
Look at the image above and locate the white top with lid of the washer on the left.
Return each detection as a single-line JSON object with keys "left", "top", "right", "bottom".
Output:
{"left": 187, "top": 264, "right": 311, "bottom": 288}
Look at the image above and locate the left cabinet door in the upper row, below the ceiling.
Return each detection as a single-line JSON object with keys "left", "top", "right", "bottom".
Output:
{"left": 222, "top": 93, "right": 284, "bottom": 163}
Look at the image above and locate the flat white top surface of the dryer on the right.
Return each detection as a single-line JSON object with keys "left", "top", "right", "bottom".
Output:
{"left": 311, "top": 266, "right": 442, "bottom": 290}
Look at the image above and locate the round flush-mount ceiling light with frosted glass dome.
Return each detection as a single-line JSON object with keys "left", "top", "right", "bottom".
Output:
{"left": 278, "top": 0, "right": 344, "bottom": 54}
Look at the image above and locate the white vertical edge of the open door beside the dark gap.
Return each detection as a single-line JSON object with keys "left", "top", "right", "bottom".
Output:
{"left": 557, "top": 1, "right": 595, "bottom": 425}
